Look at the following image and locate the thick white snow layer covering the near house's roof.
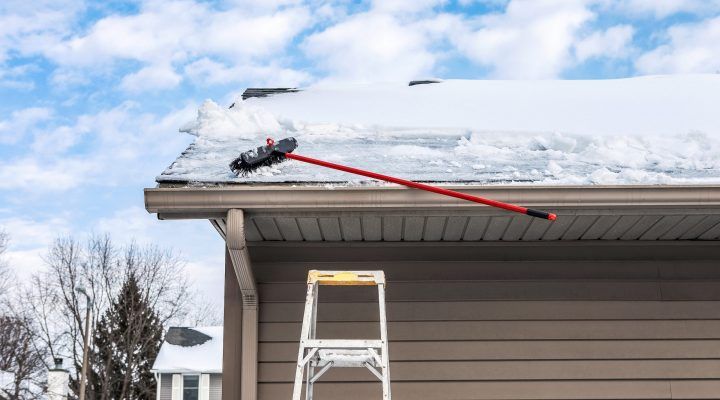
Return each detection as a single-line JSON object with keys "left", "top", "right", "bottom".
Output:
{"left": 157, "top": 74, "right": 720, "bottom": 185}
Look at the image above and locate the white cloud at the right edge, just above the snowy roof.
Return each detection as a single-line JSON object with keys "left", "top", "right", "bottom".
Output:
{"left": 635, "top": 17, "right": 720, "bottom": 74}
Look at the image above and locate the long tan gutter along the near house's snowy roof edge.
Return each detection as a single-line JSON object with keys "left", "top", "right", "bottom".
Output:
{"left": 144, "top": 184, "right": 720, "bottom": 219}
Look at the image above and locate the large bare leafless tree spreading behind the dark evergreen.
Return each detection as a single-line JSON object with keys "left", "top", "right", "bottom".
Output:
{"left": 25, "top": 235, "right": 218, "bottom": 399}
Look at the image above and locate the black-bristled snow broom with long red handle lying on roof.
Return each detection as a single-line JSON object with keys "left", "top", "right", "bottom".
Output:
{"left": 230, "top": 137, "right": 557, "bottom": 221}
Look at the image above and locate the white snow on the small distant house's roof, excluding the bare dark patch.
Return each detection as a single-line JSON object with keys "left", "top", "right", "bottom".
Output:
{"left": 152, "top": 326, "right": 223, "bottom": 373}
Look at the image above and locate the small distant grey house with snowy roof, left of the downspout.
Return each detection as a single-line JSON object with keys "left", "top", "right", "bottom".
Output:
{"left": 152, "top": 326, "right": 223, "bottom": 400}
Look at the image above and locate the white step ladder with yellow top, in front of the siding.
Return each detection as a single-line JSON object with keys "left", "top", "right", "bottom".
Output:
{"left": 292, "top": 270, "right": 391, "bottom": 400}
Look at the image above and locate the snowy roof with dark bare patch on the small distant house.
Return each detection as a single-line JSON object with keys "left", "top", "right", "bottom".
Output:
{"left": 152, "top": 326, "right": 223, "bottom": 373}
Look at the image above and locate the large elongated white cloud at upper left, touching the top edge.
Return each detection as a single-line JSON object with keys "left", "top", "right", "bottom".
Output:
{"left": 32, "top": 0, "right": 313, "bottom": 92}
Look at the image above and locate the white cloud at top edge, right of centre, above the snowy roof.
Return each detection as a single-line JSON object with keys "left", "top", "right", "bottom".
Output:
{"left": 451, "top": 0, "right": 595, "bottom": 79}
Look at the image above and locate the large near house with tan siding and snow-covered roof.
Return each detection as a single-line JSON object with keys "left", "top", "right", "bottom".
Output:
{"left": 145, "top": 75, "right": 720, "bottom": 400}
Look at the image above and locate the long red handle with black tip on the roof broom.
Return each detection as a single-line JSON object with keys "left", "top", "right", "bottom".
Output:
{"left": 285, "top": 153, "right": 557, "bottom": 221}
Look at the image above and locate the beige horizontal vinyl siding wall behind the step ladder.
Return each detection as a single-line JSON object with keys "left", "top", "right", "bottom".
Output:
{"left": 254, "top": 242, "right": 720, "bottom": 400}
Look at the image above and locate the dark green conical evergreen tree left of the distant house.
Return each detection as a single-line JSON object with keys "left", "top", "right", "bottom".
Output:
{"left": 88, "top": 274, "right": 162, "bottom": 400}
